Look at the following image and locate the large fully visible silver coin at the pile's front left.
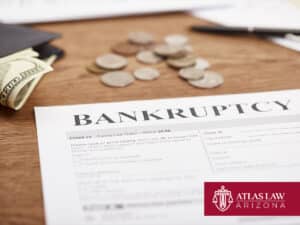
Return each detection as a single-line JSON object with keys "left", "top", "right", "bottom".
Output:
{"left": 100, "top": 71, "right": 134, "bottom": 87}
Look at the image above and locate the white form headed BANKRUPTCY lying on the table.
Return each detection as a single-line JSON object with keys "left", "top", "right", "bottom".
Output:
{"left": 35, "top": 90, "right": 300, "bottom": 225}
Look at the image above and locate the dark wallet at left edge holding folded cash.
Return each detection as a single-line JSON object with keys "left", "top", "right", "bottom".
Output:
{"left": 0, "top": 23, "right": 63, "bottom": 58}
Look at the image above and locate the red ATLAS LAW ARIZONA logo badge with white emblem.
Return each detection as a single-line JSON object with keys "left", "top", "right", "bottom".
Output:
{"left": 204, "top": 182, "right": 300, "bottom": 216}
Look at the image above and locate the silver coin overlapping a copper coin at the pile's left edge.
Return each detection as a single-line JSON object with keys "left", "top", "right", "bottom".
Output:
{"left": 96, "top": 54, "right": 128, "bottom": 70}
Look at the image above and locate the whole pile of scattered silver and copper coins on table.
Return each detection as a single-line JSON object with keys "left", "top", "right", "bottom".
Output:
{"left": 87, "top": 32, "right": 224, "bottom": 88}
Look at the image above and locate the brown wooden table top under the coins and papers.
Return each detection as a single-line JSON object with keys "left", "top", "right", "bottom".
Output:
{"left": 0, "top": 14, "right": 300, "bottom": 225}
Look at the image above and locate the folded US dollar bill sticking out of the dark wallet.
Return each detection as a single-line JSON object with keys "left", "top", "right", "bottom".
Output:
{"left": 0, "top": 49, "right": 53, "bottom": 110}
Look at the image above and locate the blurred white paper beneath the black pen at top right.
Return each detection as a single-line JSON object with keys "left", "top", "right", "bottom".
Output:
{"left": 193, "top": 0, "right": 300, "bottom": 51}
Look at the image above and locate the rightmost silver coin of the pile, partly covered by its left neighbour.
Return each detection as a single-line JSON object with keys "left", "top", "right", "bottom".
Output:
{"left": 188, "top": 71, "right": 224, "bottom": 89}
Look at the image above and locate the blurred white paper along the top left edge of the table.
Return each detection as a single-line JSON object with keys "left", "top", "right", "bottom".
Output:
{"left": 0, "top": 0, "right": 225, "bottom": 24}
